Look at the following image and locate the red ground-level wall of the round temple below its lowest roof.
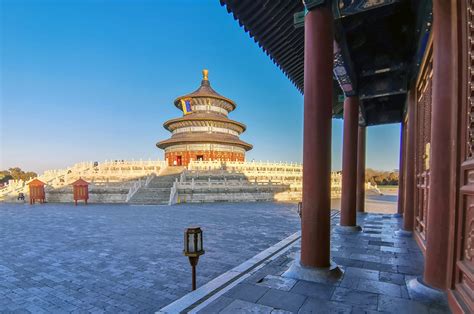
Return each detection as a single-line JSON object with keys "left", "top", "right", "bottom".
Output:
{"left": 165, "top": 151, "right": 245, "bottom": 166}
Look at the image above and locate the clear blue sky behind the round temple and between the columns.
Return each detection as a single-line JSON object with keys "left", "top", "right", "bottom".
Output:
{"left": 0, "top": 0, "right": 400, "bottom": 172}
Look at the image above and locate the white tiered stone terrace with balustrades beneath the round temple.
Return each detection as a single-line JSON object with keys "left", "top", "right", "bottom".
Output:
{"left": 0, "top": 160, "right": 377, "bottom": 203}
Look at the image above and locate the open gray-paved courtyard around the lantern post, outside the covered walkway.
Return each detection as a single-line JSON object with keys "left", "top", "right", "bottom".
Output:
{"left": 0, "top": 203, "right": 300, "bottom": 313}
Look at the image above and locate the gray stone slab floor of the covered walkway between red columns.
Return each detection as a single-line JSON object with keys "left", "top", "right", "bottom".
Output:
{"left": 200, "top": 214, "right": 449, "bottom": 314}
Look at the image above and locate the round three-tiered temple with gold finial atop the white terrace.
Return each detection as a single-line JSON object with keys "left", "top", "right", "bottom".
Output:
{"left": 156, "top": 70, "right": 252, "bottom": 166}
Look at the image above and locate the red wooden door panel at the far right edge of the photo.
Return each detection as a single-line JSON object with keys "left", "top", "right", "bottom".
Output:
{"left": 450, "top": 0, "right": 474, "bottom": 313}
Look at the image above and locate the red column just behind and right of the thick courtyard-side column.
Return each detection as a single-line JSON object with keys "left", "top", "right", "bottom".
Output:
{"left": 341, "top": 96, "right": 359, "bottom": 227}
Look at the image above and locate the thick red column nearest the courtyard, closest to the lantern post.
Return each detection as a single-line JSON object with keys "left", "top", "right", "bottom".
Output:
{"left": 301, "top": 6, "right": 334, "bottom": 267}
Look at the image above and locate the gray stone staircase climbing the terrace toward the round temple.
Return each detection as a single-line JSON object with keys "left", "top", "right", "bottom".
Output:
{"left": 129, "top": 167, "right": 185, "bottom": 205}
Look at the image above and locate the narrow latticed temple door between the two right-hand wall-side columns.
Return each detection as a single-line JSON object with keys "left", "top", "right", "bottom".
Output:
{"left": 415, "top": 39, "right": 433, "bottom": 251}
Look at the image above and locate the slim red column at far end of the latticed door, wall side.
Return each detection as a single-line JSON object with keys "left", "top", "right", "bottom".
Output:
{"left": 403, "top": 87, "right": 416, "bottom": 232}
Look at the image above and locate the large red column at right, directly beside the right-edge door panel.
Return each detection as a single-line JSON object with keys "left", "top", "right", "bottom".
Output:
{"left": 424, "top": 0, "right": 458, "bottom": 289}
